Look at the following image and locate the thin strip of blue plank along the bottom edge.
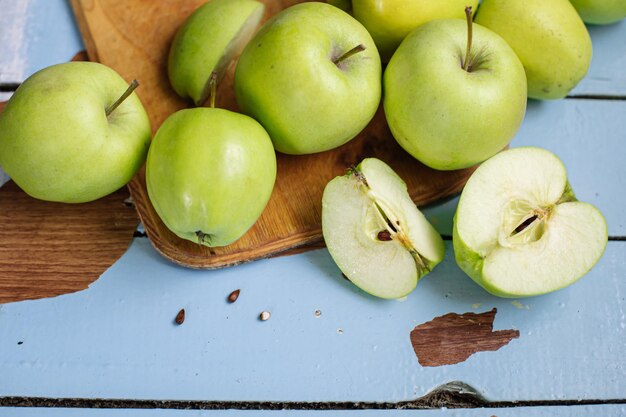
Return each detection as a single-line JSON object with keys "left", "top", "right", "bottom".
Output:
{"left": 0, "top": 404, "right": 626, "bottom": 417}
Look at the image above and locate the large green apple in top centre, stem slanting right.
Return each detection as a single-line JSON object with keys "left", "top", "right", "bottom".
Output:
{"left": 235, "top": 3, "right": 382, "bottom": 155}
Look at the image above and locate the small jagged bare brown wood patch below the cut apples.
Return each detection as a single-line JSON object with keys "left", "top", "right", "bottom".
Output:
{"left": 411, "top": 308, "right": 519, "bottom": 366}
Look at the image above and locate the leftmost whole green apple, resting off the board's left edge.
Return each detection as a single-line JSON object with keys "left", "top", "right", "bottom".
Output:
{"left": 0, "top": 62, "right": 151, "bottom": 203}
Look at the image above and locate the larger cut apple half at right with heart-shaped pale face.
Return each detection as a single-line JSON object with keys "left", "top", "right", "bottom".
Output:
{"left": 453, "top": 147, "right": 608, "bottom": 297}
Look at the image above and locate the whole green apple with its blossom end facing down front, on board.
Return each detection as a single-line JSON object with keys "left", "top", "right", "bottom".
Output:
{"left": 146, "top": 108, "right": 276, "bottom": 246}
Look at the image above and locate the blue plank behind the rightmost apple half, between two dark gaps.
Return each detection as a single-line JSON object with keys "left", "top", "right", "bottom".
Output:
{"left": 424, "top": 98, "right": 626, "bottom": 236}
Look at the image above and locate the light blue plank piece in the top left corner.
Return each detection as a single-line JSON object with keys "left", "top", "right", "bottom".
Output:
{"left": 0, "top": 0, "right": 84, "bottom": 83}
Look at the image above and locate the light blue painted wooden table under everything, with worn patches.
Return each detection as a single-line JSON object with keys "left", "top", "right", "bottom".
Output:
{"left": 0, "top": 0, "right": 626, "bottom": 417}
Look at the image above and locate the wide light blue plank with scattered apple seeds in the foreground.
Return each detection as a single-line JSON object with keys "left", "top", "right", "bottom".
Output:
{"left": 0, "top": 239, "right": 626, "bottom": 402}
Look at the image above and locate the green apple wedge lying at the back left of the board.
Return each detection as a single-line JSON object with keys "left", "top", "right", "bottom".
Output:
{"left": 168, "top": 0, "right": 265, "bottom": 106}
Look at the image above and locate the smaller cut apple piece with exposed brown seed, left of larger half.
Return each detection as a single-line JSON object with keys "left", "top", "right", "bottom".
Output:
{"left": 322, "top": 158, "right": 444, "bottom": 298}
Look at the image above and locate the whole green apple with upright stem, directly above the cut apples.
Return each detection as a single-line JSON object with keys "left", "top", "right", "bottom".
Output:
{"left": 383, "top": 19, "right": 526, "bottom": 170}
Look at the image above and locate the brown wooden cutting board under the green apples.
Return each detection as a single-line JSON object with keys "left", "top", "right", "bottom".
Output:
{"left": 71, "top": 0, "right": 472, "bottom": 268}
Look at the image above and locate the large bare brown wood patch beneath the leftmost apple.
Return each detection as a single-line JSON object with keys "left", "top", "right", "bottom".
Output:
{"left": 0, "top": 181, "right": 138, "bottom": 303}
